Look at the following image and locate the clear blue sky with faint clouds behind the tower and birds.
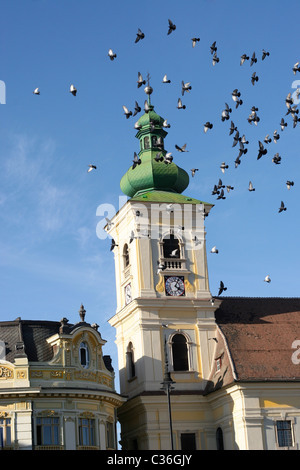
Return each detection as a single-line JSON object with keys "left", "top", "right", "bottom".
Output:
{"left": 0, "top": 0, "right": 300, "bottom": 382}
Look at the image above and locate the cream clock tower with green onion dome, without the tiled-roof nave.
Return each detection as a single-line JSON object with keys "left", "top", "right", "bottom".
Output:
{"left": 106, "top": 84, "right": 218, "bottom": 450}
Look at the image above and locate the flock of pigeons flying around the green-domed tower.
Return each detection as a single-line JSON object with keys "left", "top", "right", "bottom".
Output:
{"left": 33, "top": 19, "right": 300, "bottom": 295}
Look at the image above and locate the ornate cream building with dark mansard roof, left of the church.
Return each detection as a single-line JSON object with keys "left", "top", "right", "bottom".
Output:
{"left": 0, "top": 306, "right": 124, "bottom": 450}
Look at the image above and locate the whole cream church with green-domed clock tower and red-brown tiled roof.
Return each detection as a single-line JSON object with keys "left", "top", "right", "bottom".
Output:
{"left": 106, "top": 85, "right": 300, "bottom": 450}
